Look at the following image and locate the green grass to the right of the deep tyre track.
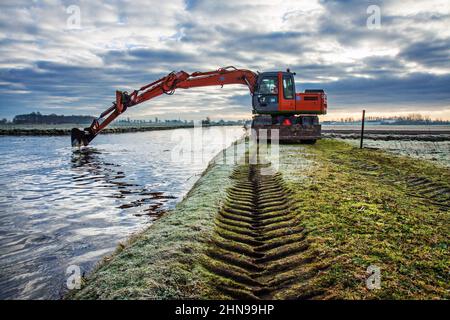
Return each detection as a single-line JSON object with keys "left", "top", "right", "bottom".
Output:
{"left": 280, "top": 140, "right": 450, "bottom": 299}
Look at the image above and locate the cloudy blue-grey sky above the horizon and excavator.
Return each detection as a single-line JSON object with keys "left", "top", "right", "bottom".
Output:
{"left": 0, "top": 0, "right": 450, "bottom": 119}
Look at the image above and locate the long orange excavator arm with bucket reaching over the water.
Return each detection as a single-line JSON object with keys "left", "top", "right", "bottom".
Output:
{"left": 72, "top": 67, "right": 258, "bottom": 146}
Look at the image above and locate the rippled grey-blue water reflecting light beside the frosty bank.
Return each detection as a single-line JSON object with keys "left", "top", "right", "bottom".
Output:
{"left": 0, "top": 127, "right": 243, "bottom": 299}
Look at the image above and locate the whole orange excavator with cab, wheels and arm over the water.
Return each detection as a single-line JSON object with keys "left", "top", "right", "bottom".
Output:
{"left": 71, "top": 67, "right": 327, "bottom": 146}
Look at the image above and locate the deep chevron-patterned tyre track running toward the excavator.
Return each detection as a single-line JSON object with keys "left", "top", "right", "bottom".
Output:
{"left": 203, "top": 165, "right": 317, "bottom": 299}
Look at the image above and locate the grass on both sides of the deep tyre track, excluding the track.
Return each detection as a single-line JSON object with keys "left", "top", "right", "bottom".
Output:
{"left": 67, "top": 140, "right": 450, "bottom": 299}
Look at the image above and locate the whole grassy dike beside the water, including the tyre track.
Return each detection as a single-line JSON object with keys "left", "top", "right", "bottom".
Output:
{"left": 67, "top": 140, "right": 450, "bottom": 299}
